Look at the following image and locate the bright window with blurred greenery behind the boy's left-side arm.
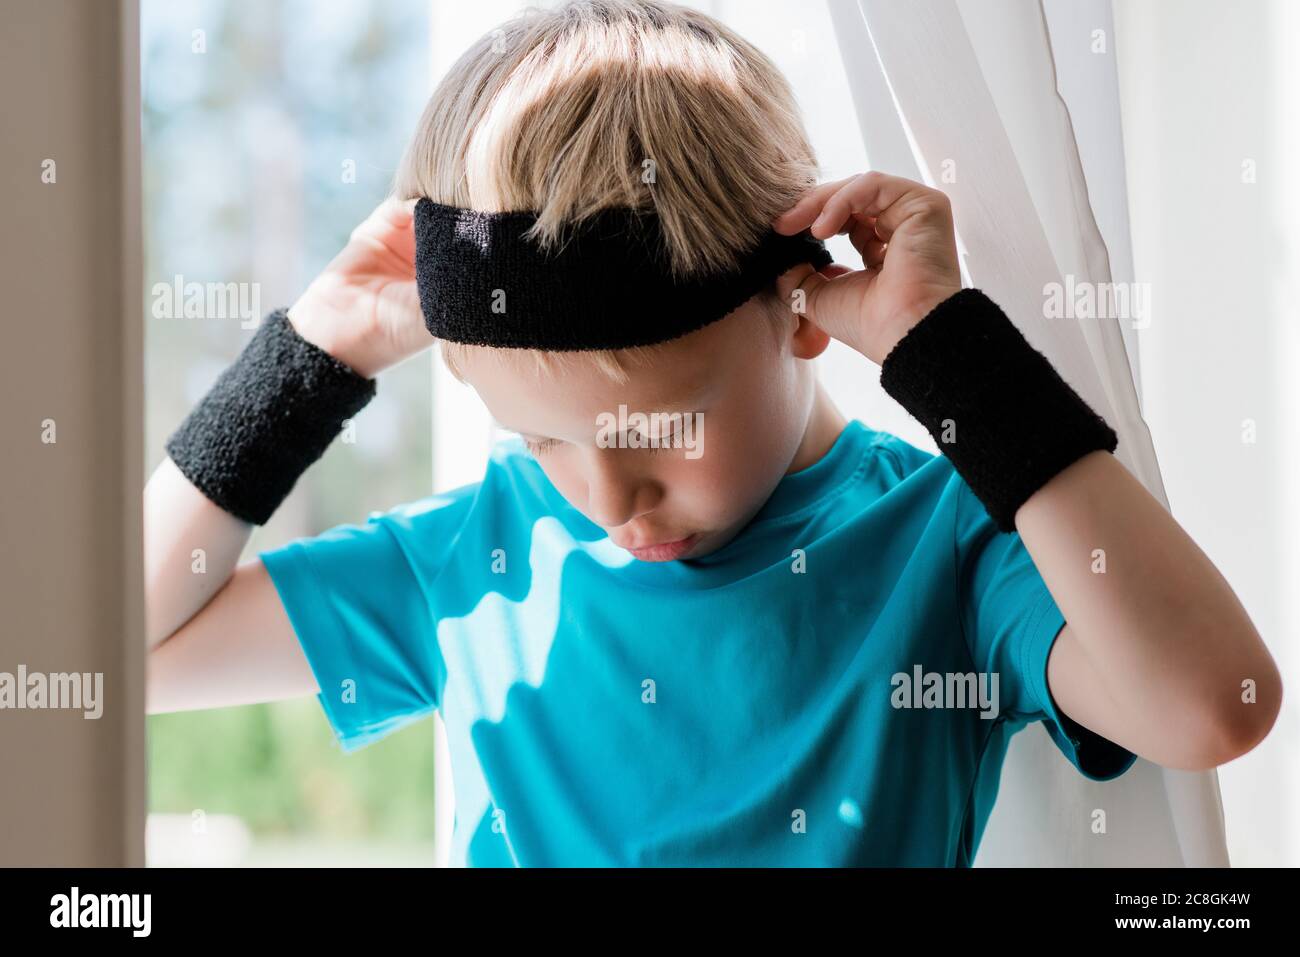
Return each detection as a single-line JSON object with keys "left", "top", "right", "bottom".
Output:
{"left": 140, "top": 0, "right": 433, "bottom": 865}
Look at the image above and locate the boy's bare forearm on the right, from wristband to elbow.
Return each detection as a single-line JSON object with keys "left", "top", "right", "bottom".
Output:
{"left": 1015, "top": 451, "right": 1282, "bottom": 752}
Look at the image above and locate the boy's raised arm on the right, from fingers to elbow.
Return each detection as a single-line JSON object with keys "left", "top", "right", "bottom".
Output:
{"left": 772, "top": 172, "right": 1282, "bottom": 768}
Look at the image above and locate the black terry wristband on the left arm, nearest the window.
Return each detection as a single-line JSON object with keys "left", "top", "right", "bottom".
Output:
{"left": 166, "top": 308, "right": 374, "bottom": 525}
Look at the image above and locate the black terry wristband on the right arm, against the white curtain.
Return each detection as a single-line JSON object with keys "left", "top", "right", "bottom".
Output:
{"left": 880, "top": 289, "right": 1119, "bottom": 532}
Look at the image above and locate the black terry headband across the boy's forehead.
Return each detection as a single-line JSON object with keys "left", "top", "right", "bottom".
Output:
{"left": 415, "top": 198, "right": 832, "bottom": 351}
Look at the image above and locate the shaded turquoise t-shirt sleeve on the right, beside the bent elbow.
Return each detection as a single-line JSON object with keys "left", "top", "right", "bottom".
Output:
{"left": 954, "top": 479, "right": 1138, "bottom": 781}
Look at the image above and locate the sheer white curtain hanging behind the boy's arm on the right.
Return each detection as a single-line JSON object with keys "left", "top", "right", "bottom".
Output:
{"left": 828, "top": 0, "right": 1229, "bottom": 866}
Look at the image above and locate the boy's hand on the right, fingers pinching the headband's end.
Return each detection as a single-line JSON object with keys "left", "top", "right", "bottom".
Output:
{"left": 772, "top": 172, "right": 962, "bottom": 364}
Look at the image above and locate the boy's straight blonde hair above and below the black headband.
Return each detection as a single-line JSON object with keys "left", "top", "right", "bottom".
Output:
{"left": 394, "top": 0, "right": 819, "bottom": 381}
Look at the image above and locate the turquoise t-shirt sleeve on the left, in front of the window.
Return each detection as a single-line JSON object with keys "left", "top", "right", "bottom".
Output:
{"left": 257, "top": 490, "right": 471, "bottom": 752}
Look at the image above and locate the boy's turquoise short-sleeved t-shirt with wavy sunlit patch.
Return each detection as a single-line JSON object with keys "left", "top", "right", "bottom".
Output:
{"left": 259, "top": 421, "right": 1136, "bottom": 866}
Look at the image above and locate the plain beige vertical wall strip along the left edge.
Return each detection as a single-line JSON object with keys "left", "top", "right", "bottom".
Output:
{"left": 0, "top": 0, "right": 144, "bottom": 866}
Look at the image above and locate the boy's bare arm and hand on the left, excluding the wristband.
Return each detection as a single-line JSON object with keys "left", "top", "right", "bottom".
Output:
{"left": 144, "top": 199, "right": 433, "bottom": 714}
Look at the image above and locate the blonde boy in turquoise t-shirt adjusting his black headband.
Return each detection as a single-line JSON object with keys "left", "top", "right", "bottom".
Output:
{"left": 146, "top": 0, "right": 1281, "bottom": 866}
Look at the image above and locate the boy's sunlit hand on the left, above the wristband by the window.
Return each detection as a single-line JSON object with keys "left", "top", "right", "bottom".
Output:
{"left": 289, "top": 198, "right": 433, "bottom": 378}
